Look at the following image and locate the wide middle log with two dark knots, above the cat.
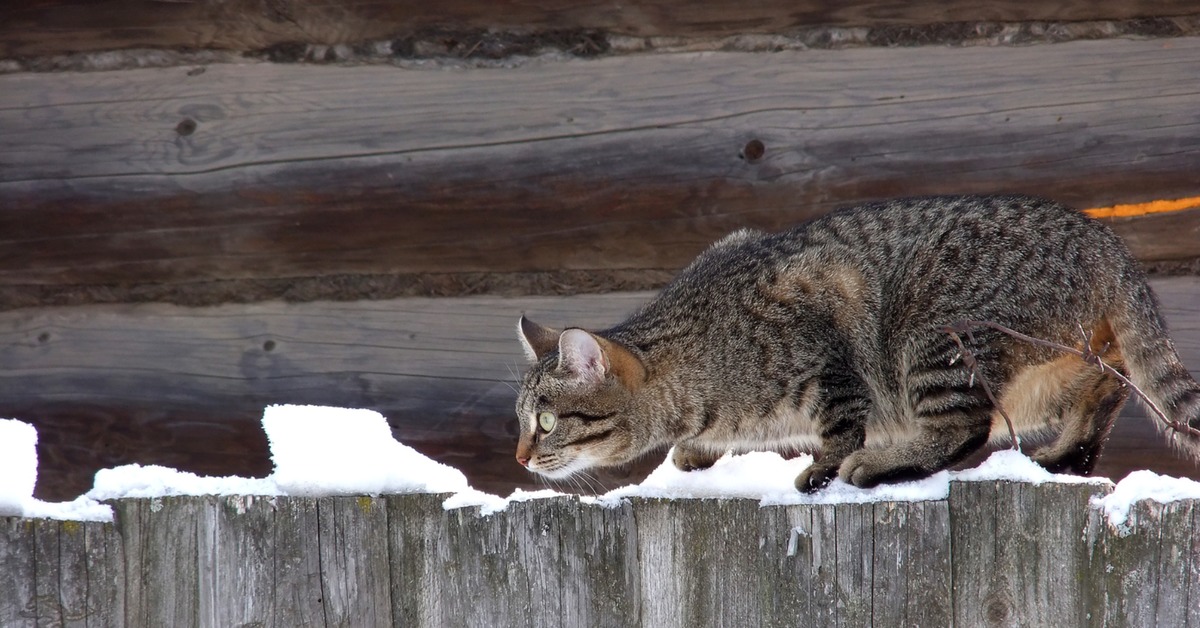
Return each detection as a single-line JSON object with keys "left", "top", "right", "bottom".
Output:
{"left": 0, "top": 38, "right": 1200, "bottom": 307}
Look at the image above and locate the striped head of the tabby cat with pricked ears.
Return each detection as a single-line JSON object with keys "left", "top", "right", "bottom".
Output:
{"left": 516, "top": 316, "right": 646, "bottom": 478}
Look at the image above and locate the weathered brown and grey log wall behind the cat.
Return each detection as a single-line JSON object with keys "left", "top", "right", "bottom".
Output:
{"left": 0, "top": 0, "right": 1200, "bottom": 511}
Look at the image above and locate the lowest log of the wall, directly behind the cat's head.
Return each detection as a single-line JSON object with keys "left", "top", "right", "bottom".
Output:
{"left": 0, "top": 277, "right": 1200, "bottom": 500}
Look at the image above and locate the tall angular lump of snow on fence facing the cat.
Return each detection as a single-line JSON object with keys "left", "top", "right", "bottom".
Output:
{"left": 263, "top": 406, "right": 469, "bottom": 496}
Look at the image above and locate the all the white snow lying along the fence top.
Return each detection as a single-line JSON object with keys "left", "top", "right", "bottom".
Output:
{"left": 7, "top": 406, "right": 1200, "bottom": 528}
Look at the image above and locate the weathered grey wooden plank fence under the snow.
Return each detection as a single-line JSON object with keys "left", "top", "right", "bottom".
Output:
{"left": 0, "top": 482, "right": 1200, "bottom": 627}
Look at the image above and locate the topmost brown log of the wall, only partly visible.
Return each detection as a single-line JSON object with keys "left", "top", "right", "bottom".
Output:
{"left": 0, "top": 0, "right": 1195, "bottom": 59}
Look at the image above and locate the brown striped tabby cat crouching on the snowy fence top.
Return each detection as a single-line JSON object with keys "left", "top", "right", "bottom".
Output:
{"left": 516, "top": 196, "right": 1200, "bottom": 491}
